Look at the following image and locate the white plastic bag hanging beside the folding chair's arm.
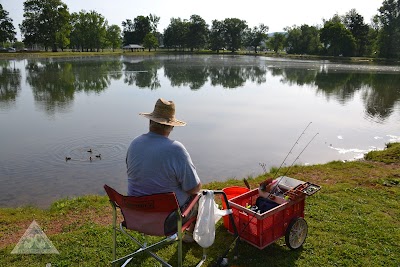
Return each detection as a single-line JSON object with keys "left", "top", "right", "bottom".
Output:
{"left": 193, "top": 190, "right": 231, "bottom": 248}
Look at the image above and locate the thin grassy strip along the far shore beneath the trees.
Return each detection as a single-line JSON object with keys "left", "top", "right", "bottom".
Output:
{"left": 0, "top": 49, "right": 400, "bottom": 65}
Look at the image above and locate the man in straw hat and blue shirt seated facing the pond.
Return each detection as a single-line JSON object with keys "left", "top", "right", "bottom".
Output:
{"left": 126, "top": 98, "right": 201, "bottom": 242}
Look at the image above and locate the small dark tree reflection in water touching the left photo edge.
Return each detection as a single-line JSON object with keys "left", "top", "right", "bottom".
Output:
{"left": 0, "top": 61, "right": 21, "bottom": 107}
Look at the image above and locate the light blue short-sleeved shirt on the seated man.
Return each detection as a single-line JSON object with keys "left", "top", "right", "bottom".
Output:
{"left": 126, "top": 132, "right": 200, "bottom": 206}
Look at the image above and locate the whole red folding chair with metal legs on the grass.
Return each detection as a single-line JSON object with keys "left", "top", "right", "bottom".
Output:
{"left": 104, "top": 185, "right": 206, "bottom": 267}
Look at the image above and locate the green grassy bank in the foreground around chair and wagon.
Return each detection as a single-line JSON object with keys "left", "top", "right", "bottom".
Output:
{"left": 0, "top": 143, "right": 400, "bottom": 267}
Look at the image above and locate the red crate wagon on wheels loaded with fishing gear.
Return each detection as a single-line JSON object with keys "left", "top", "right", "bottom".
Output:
{"left": 225, "top": 176, "right": 320, "bottom": 249}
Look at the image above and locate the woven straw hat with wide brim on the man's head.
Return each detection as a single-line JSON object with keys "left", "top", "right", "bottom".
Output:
{"left": 139, "top": 98, "right": 186, "bottom": 126}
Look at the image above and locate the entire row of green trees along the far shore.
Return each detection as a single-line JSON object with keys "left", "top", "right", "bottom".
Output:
{"left": 0, "top": 0, "right": 400, "bottom": 59}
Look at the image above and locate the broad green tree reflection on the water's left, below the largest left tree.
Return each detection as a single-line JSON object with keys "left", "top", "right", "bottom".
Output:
{"left": 25, "top": 60, "right": 122, "bottom": 114}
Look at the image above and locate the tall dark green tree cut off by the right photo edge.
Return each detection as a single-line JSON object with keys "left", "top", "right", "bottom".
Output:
{"left": 377, "top": 0, "right": 400, "bottom": 58}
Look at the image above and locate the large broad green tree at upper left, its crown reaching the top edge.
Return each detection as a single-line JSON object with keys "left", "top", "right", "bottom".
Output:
{"left": 20, "top": 0, "right": 70, "bottom": 51}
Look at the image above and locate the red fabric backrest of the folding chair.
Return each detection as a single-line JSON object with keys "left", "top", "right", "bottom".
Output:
{"left": 104, "top": 185, "right": 179, "bottom": 236}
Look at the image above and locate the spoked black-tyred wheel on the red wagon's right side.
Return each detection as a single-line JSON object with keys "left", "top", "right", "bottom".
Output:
{"left": 285, "top": 217, "right": 308, "bottom": 250}
